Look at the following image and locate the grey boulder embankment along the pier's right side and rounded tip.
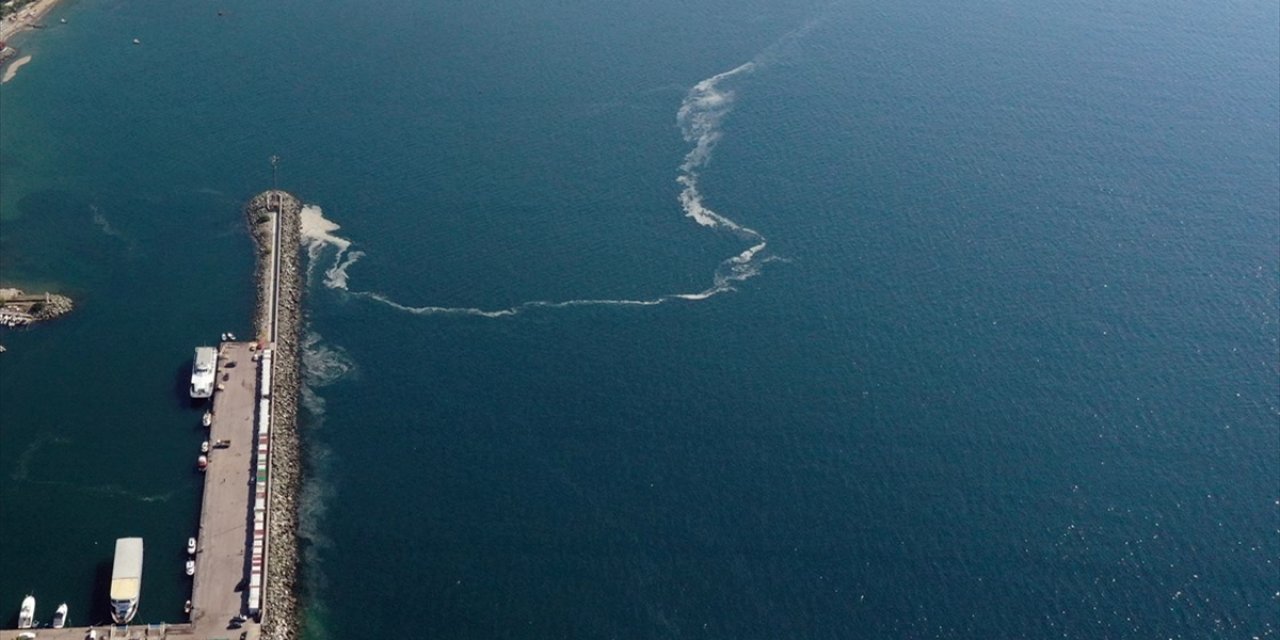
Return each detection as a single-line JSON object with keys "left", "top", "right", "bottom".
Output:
{"left": 244, "top": 191, "right": 302, "bottom": 640}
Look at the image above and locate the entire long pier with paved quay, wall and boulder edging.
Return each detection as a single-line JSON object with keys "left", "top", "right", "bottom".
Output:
{"left": 0, "top": 191, "right": 302, "bottom": 640}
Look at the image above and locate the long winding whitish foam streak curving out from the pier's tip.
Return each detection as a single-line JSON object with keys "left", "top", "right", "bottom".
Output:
{"left": 302, "top": 18, "right": 819, "bottom": 317}
